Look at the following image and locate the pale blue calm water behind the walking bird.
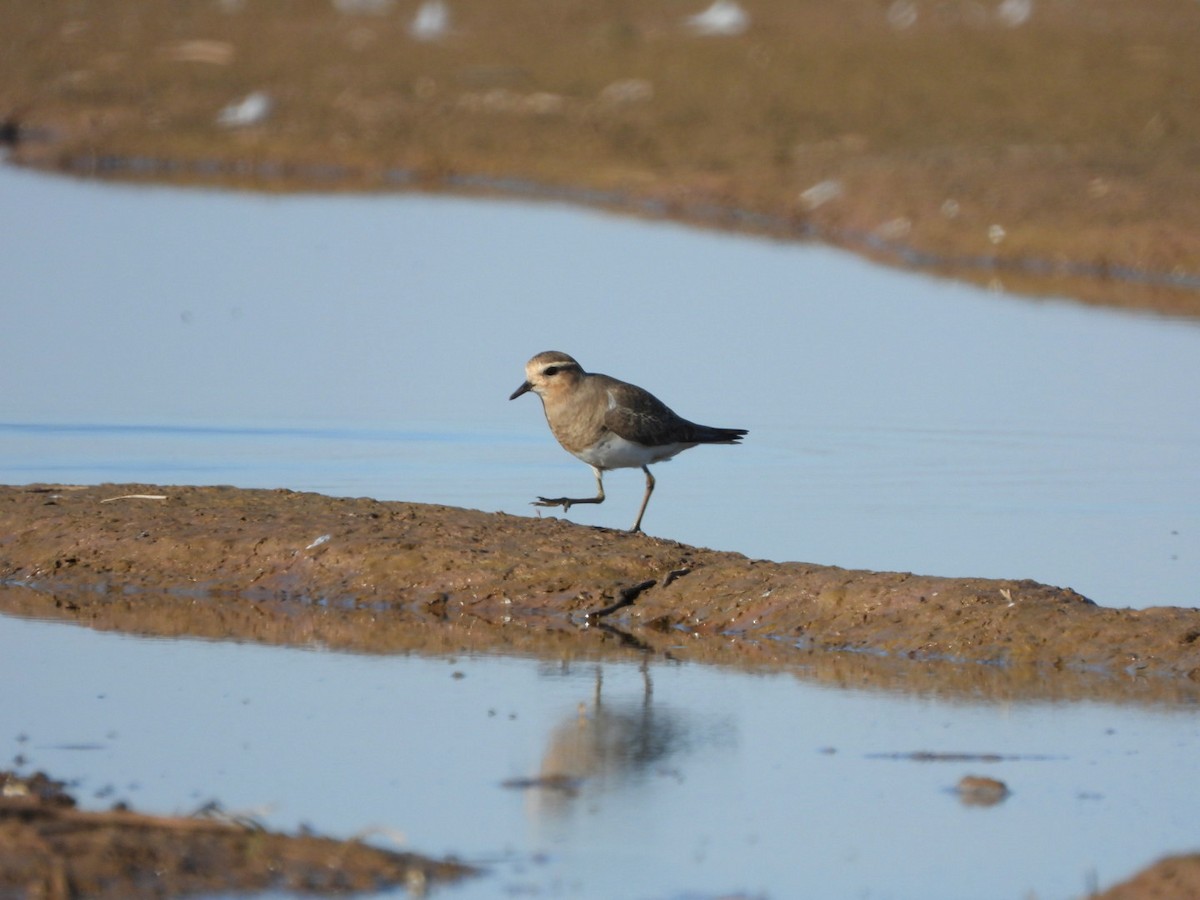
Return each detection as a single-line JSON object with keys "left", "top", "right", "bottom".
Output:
{"left": 0, "top": 167, "right": 1200, "bottom": 606}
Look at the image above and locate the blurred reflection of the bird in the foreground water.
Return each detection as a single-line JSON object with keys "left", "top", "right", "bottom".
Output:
{"left": 527, "top": 661, "right": 690, "bottom": 817}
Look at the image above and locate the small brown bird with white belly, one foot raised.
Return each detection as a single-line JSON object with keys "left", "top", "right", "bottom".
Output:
{"left": 509, "top": 350, "right": 748, "bottom": 533}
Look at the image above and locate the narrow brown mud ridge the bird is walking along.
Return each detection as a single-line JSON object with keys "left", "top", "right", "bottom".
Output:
{"left": 7, "top": 485, "right": 1200, "bottom": 690}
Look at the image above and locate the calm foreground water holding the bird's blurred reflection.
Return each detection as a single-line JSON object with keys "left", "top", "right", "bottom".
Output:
{"left": 0, "top": 618, "right": 1200, "bottom": 900}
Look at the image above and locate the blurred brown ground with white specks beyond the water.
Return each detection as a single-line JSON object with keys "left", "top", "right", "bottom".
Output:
{"left": 0, "top": 0, "right": 1200, "bottom": 316}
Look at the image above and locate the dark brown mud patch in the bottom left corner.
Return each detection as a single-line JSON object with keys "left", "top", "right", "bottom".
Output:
{"left": 0, "top": 772, "right": 474, "bottom": 900}
